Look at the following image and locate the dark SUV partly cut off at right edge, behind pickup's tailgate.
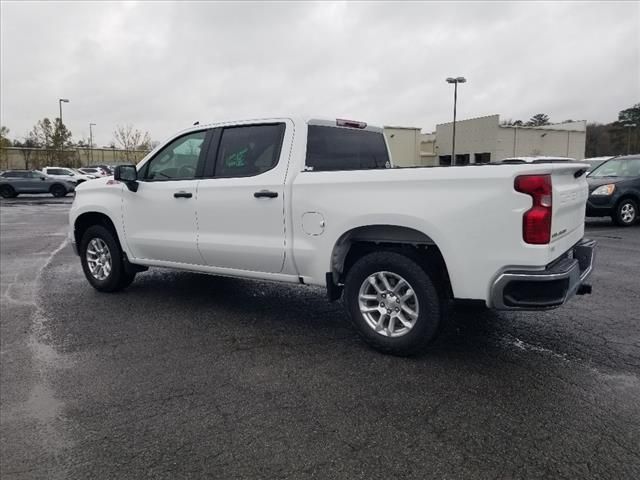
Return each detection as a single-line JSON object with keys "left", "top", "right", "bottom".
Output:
{"left": 587, "top": 155, "right": 640, "bottom": 227}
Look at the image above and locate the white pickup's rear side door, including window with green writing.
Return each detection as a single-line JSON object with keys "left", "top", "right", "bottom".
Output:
{"left": 196, "top": 120, "right": 293, "bottom": 273}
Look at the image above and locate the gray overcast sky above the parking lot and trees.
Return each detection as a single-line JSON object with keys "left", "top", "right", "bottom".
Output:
{"left": 0, "top": 1, "right": 640, "bottom": 145}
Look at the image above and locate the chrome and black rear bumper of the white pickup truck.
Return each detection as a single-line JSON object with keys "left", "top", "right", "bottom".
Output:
{"left": 490, "top": 239, "right": 596, "bottom": 310}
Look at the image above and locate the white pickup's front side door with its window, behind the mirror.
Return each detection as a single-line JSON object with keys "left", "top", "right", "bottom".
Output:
{"left": 122, "top": 130, "right": 207, "bottom": 264}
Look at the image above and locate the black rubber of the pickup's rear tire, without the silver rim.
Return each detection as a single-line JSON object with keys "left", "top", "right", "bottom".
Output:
{"left": 344, "top": 251, "right": 446, "bottom": 356}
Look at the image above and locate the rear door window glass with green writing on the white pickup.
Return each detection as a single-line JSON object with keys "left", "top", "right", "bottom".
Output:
{"left": 214, "top": 123, "right": 285, "bottom": 177}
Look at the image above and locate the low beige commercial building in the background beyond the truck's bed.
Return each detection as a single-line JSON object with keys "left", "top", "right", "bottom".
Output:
{"left": 384, "top": 115, "right": 587, "bottom": 167}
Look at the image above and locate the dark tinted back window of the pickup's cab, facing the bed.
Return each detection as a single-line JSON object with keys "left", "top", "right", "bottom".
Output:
{"left": 306, "top": 125, "right": 389, "bottom": 171}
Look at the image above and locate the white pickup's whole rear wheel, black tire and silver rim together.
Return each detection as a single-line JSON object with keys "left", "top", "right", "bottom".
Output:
{"left": 344, "top": 251, "right": 442, "bottom": 356}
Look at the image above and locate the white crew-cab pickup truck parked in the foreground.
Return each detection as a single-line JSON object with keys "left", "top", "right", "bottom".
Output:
{"left": 70, "top": 118, "right": 595, "bottom": 355}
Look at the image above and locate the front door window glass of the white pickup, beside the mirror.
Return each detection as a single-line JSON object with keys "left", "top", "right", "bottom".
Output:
{"left": 144, "top": 131, "right": 207, "bottom": 180}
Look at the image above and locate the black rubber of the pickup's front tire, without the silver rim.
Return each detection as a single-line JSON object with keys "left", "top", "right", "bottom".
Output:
{"left": 80, "top": 225, "right": 136, "bottom": 292}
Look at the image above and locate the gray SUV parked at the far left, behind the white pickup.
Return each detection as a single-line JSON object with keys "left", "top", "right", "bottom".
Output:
{"left": 0, "top": 170, "right": 76, "bottom": 198}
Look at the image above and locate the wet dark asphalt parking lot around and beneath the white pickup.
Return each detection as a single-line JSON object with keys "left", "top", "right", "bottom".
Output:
{"left": 0, "top": 196, "right": 640, "bottom": 479}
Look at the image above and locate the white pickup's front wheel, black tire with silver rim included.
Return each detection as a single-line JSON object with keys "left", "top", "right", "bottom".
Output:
{"left": 80, "top": 225, "right": 135, "bottom": 292}
